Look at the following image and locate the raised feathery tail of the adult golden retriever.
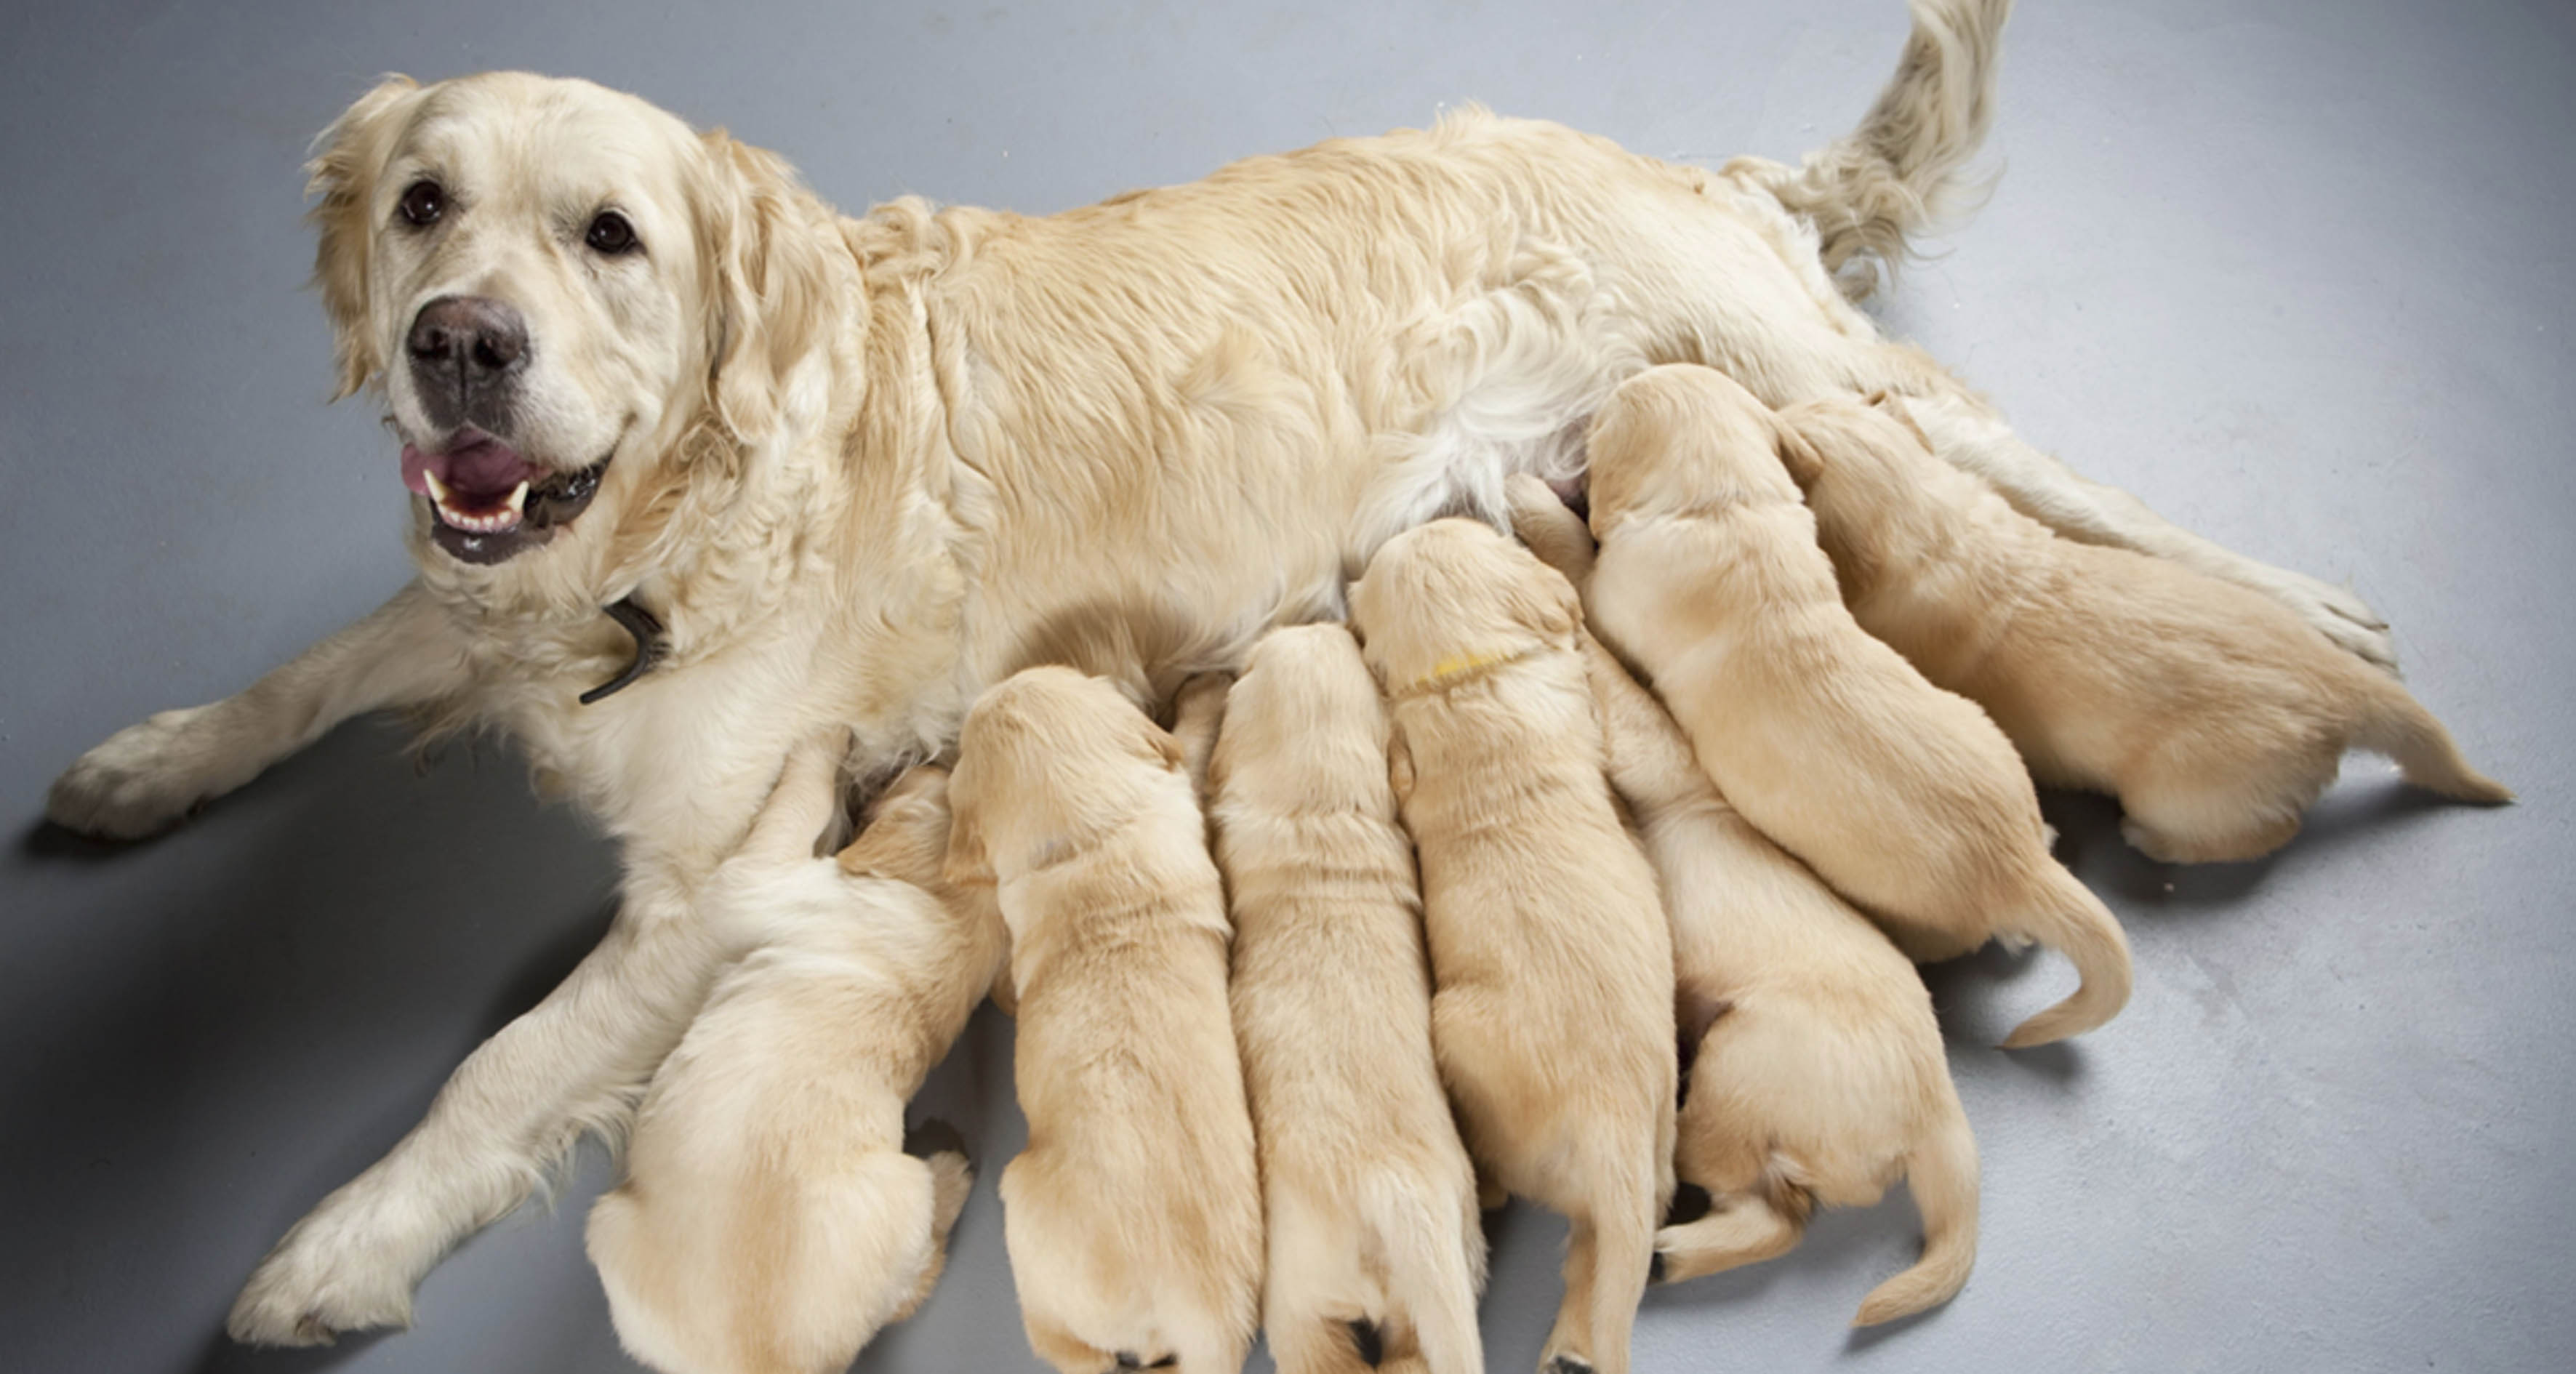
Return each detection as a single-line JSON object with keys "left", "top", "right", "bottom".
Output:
{"left": 1765, "top": 0, "right": 2012, "bottom": 302}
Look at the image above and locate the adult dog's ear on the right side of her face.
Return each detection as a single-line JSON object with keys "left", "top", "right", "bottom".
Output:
{"left": 701, "top": 129, "right": 840, "bottom": 441}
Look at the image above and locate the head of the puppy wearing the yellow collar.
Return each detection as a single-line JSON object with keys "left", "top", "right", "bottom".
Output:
{"left": 1350, "top": 518, "right": 1584, "bottom": 696}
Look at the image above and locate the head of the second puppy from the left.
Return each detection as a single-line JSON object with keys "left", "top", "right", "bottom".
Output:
{"left": 948, "top": 667, "right": 1187, "bottom": 884}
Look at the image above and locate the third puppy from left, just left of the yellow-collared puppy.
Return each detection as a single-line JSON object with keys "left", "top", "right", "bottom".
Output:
{"left": 1211, "top": 624, "right": 1484, "bottom": 1374}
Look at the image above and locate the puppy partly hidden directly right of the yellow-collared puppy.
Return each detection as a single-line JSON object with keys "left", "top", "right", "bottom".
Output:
{"left": 1512, "top": 477, "right": 1978, "bottom": 1325}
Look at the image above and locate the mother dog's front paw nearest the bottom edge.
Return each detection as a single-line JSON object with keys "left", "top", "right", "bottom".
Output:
{"left": 224, "top": 1191, "right": 425, "bottom": 1346}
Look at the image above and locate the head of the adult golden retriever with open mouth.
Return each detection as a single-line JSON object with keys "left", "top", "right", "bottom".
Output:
{"left": 307, "top": 72, "right": 832, "bottom": 577}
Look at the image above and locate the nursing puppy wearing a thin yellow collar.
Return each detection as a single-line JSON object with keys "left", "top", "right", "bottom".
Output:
{"left": 1350, "top": 521, "right": 1674, "bottom": 1374}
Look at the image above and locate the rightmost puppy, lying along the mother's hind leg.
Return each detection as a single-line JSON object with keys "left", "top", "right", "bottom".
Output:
{"left": 1780, "top": 400, "right": 2514, "bottom": 864}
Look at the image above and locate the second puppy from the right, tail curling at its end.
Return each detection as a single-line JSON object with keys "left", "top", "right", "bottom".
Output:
{"left": 1589, "top": 366, "right": 2130, "bottom": 1047}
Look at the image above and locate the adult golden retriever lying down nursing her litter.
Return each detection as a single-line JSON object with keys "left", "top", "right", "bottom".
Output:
{"left": 35, "top": 0, "right": 2388, "bottom": 1343}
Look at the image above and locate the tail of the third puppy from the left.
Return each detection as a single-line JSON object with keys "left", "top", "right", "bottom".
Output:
{"left": 1360, "top": 1170, "right": 1484, "bottom": 1374}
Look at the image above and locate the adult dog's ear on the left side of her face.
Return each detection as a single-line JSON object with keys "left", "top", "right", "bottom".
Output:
{"left": 304, "top": 75, "right": 420, "bottom": 400}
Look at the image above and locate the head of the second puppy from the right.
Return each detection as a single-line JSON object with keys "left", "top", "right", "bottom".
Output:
{"left": 1584, "top": 363, "right": 1798, "bottom": 537}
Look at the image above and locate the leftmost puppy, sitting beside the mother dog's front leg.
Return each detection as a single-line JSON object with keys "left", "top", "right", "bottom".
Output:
{"left": 590, "top": 750, "right": 1002, "bottom": 1374}
